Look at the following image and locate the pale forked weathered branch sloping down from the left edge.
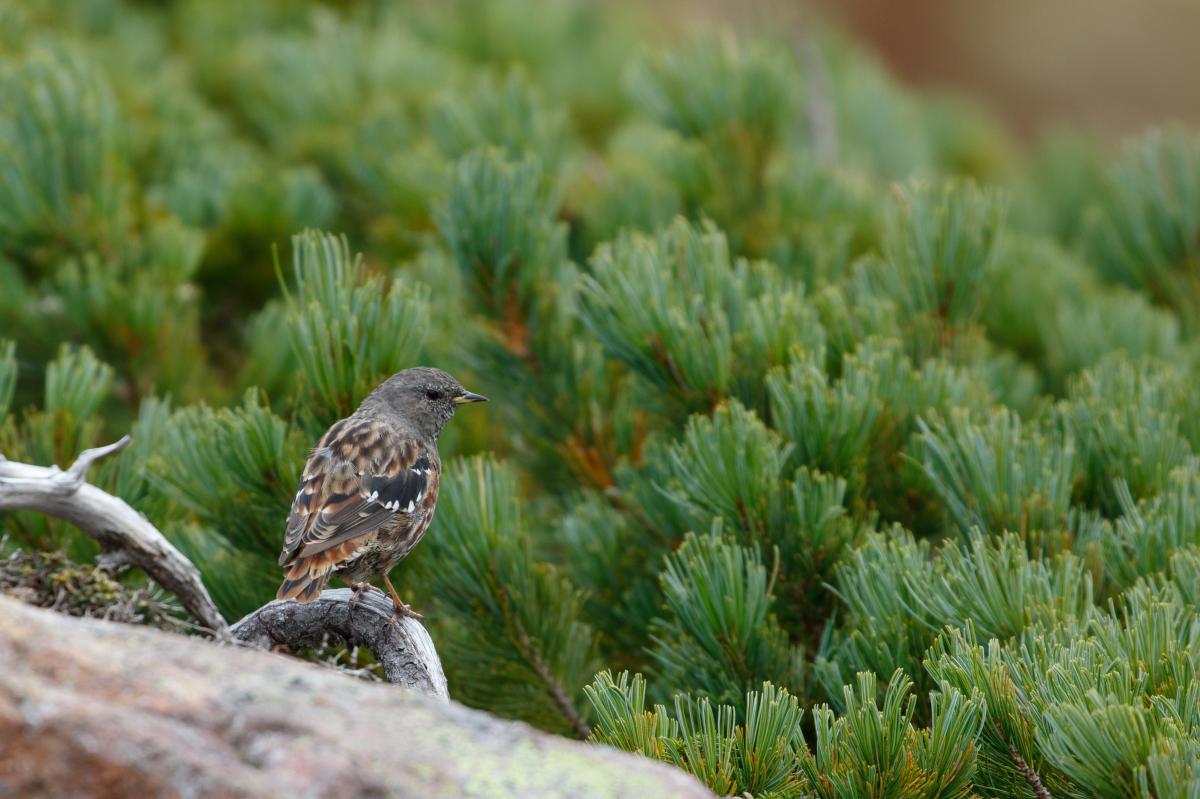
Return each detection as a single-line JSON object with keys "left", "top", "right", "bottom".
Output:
{"left": 0, "top": 435, "right": 226, "bottom": 630}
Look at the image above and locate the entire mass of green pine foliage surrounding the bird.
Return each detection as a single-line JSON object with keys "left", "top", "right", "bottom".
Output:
{"left": 7, "top": 0, "right": 1200, "bottom": 799}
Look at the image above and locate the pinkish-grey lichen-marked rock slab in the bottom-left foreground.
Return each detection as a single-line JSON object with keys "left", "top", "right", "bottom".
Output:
{"left": 0, "top": 597, "right": 713, "bottom": 799}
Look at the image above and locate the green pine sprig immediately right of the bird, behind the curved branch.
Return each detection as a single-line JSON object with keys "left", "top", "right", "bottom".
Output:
{"left": 406, "top": 457, "right": 596, "bottom": 734}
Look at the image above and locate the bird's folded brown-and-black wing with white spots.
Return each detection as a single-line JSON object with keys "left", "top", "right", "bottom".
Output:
{"left": 280, "top": 419, "right": 436, "bottom": 565}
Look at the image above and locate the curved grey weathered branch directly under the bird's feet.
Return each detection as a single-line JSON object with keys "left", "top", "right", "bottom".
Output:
{"left": 229, "top": 588, "right": 450, "bottom": 699}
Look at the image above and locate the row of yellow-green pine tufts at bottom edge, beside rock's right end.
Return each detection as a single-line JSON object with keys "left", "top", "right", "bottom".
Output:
{"left": 587, "top": 671, "right": 985, "bottom": 799}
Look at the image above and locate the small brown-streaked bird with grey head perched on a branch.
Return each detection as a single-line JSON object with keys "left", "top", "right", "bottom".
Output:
{"left": 276, "top": 366, "right": 487, "bottom": 621}
